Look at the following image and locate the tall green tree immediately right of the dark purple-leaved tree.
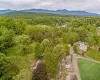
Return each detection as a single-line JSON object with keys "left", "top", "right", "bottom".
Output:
{"left": 44, "top": 52, "right": 59, "bottom": 77}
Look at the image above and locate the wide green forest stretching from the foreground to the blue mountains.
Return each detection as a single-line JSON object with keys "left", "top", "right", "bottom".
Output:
{"left": 0, "top": 12, "right": 100, "bottom": 80}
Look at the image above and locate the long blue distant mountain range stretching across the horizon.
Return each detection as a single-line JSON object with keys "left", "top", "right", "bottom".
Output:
{"left": 0, "top": 9, "right": 100, "bottom": 16}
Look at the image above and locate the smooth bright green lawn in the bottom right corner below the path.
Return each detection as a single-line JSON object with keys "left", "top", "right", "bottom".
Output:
{"left": 78, "top": 59, "right": 100, "bottom": 80}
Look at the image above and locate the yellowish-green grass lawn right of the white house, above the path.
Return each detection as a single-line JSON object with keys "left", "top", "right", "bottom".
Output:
{"left": 86, "top": 49, "right": 100, "bottom": 61}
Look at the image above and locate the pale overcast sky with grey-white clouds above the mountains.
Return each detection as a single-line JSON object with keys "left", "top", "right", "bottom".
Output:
{"left": 0, "top": 0, "right": 100, "bottom": 13}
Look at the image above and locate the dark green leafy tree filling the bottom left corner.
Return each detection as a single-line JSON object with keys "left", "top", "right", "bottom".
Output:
{"left": 0, "top": 53, "right": 19, "bottom": 80}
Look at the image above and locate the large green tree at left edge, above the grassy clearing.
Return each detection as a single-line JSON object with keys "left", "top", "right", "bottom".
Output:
{"left": 0, "top": 27, "right": 14, "bottom": 53}
